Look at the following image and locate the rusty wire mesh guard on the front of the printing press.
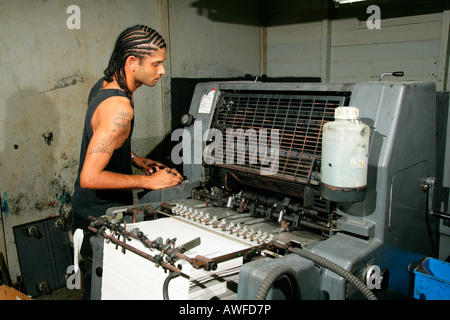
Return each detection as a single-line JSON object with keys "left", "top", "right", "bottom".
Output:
{"left": 212, "top": 92, "right": 345, "bottom": 183}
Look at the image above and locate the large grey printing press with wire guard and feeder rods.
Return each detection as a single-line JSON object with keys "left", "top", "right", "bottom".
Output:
{"left": 91, "top": 81, "right": 448, "bottom": 300}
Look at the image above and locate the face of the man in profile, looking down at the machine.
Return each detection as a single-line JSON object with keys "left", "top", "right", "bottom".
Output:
{"left": 134, "top": 48, "right": 166, "bottom": 87}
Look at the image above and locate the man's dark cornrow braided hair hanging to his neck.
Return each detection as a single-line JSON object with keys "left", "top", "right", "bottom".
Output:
{"left": 104, "top": 25, "right": 166, "bottom": 99}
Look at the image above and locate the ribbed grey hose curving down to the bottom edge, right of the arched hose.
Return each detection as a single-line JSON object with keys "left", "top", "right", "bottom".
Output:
{"left": 289, "top": 248, "right": 378, "bottom": 300}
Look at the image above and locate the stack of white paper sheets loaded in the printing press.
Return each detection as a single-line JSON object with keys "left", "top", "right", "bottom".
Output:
{"left": 101, "top": 218, "right": 250, "bottom": 300}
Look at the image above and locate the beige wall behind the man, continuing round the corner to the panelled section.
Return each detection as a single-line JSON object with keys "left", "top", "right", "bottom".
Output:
{"left": 0, "top": 0, "right": 260, "bottom": 280}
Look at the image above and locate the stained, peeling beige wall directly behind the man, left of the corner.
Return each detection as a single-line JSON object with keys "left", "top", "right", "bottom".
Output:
{"left": 0, "top": 0, "right": 163, "bottom": 279}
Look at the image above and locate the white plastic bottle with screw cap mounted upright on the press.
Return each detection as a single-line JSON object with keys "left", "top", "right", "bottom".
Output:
{"left": 320, "top": 107, "right": 370, "bottom": 202}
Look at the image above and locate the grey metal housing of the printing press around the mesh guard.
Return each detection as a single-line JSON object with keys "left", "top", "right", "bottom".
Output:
{"left": 140, "top": 81, "right": 440, "bottom": 300}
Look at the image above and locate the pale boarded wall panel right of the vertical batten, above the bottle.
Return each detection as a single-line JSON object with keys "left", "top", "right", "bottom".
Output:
{"left": 330, "top": 11, "right": 442, "bottom": 82}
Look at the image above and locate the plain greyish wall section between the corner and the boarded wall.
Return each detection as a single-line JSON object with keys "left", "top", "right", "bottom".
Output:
{"left": 169, "top": 0, "right": 260, "bottom": 78}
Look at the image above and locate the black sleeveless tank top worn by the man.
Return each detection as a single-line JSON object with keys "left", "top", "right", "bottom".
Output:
{"left": 71, "top": 78, "right": 134, "bottom": 229}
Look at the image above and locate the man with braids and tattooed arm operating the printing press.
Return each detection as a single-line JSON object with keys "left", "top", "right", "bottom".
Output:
{"left": 72, "top": 25, "right": 183, "bottom": 298}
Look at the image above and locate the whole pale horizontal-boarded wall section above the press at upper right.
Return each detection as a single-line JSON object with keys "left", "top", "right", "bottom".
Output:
{"left": 267, "top": 5, "right": 449, "bottom": 89}
